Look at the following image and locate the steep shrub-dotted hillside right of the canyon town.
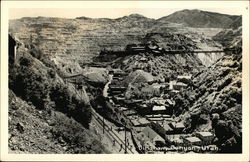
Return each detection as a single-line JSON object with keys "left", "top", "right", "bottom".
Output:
{"left": 180, "top": 54, "right": 242, "bottom": 152}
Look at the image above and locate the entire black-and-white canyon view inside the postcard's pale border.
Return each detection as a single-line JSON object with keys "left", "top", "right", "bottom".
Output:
{"left": 1, "top": 2, "right": 249, "bottom": 160}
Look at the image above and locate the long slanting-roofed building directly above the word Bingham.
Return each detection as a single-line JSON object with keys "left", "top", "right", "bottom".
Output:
{"left": 142, "top": 126, "right": 165, "bottom": 146}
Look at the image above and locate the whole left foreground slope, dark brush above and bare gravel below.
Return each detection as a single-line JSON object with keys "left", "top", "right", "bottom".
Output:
{"left": 9, "top": 41, "right": 108, "bottom": 153}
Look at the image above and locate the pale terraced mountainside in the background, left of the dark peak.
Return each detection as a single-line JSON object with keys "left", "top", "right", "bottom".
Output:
{"left": 9, "top": 15, "right": 154, "bottom": 69}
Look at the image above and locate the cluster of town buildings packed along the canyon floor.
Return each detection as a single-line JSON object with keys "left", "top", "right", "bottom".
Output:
{"left": 103, "top": 69, "right": 214, "bottom": 153}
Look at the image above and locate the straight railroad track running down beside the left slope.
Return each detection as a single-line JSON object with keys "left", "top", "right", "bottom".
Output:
{"left": 91, "top": 111, "right": 134, "bottom": 154}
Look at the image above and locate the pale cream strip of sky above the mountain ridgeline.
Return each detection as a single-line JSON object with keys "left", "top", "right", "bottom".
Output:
{"left": 9, "top": 8, "right": 241, "bottom": 19}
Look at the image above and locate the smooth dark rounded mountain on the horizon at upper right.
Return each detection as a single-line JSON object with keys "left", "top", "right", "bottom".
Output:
{"left": 158, "top": 10, "right": 239, "bottom": 28}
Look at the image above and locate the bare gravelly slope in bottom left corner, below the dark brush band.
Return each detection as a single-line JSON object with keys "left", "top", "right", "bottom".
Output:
{"left": 8, "top": 91, "right": 108, "bottom": 154}
